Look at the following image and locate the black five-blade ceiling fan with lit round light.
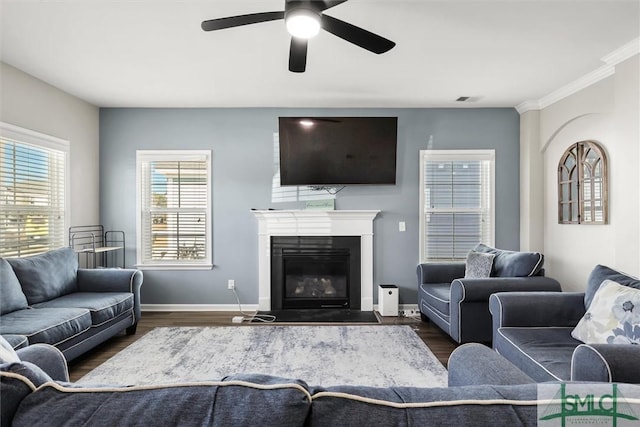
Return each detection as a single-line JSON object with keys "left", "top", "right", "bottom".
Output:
{"left": 202, "top": 0, "right": 396, "bottom": 73}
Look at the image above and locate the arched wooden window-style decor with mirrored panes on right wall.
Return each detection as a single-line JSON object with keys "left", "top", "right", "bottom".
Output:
{"left": 558, "top": 141, "right": 608, "bottom": 224}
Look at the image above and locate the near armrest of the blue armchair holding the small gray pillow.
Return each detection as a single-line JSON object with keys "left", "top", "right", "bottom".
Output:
{"left": 451, "top": 276, "right": 561, "bottom": 305}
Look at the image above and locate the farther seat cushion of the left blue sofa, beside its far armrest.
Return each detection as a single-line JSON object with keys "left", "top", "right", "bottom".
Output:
{"left": 33, "top": 292, "right": 133, "bottom": 326}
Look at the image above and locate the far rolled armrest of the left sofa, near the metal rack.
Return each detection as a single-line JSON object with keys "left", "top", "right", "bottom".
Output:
{"left": 78, "top": 268, "right": 142, "bottom": 322}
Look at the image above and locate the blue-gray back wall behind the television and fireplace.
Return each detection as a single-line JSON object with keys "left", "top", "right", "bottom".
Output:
{"left": 100, "top": 108, "right": 520, "bottom": 304}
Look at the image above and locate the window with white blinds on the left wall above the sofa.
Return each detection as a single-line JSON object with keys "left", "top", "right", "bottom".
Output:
{"left": 0, "top": 123, "right": 69, "bottom": 257}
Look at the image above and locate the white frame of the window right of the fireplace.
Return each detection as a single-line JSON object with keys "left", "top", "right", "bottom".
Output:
{"left": 418, "top": 149, "right": 496, "bottom": 263}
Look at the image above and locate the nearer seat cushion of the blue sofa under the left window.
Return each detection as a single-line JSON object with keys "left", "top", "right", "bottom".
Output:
{"left": 0, "top": 308, "right": 91, "bottom": 345}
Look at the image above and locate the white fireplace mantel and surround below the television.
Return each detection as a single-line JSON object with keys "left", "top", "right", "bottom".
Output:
{"left": 253, "top": 210, "right": 380, "bottom": 311}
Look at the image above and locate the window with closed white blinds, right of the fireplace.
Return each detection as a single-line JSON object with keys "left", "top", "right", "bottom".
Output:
{"left": 420, "top": 150, "right": 495, "bottom": 262}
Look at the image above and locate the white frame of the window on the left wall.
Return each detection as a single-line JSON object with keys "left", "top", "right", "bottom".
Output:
{"left": 0, "top": 122, "right": 71, "bottom": 257}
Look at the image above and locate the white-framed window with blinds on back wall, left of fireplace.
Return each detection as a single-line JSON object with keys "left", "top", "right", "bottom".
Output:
{"left": 136, "top": 150, "right": 212, "bottom": 269}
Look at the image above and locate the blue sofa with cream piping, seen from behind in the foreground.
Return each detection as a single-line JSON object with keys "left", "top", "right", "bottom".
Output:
{"left": 8, "top": 338, "right": 640, "bottom": 427}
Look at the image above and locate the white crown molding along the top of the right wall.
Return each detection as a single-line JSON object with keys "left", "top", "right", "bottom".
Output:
{"left": 516, "top": 38, "right": 640, "bottom": 114}
